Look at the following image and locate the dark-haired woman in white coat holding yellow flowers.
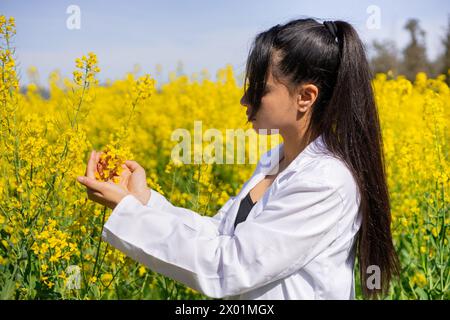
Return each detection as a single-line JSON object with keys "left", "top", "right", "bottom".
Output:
{"left": 79, "top": 19, "right": 398, "bottom": 299}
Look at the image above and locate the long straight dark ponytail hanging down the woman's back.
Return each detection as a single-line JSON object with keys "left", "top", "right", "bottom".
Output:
{"left": 322, "top": 21, "right": 400, "bottom": 297}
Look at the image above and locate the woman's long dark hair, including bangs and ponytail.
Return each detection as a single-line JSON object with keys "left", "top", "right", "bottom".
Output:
{"left": 244, "top": 18, "right": 400, "bottom": 298}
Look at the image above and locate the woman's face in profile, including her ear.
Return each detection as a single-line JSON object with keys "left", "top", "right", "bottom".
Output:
{"left": 240, "top": 67, "right": 318, "bottom": 134}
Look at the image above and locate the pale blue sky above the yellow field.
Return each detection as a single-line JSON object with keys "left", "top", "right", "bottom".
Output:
{"left": 0, "top": 0, "right": 450, "bottom": 84}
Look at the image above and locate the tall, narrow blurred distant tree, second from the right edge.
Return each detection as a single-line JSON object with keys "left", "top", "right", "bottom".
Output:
{"left": 400, "top": 19, "right": 430, "bottom": 80}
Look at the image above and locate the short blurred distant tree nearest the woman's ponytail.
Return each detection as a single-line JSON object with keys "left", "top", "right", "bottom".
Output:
{"left": 370, "top": 40, "right": 399, "bottom": 75}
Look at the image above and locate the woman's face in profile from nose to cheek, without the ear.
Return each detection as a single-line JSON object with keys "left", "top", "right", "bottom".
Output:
{"left": 241, "top": 72, "right": 297, "bottom": 134}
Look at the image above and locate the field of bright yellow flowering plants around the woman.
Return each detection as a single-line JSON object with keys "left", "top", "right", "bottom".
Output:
{"left": 0, "top": 16, "right": 450, "bottom": 299}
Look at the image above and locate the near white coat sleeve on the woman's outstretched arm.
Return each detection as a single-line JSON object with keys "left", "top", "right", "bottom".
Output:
{"left": 102, "top": 179, "right": 343, "bottom": 298}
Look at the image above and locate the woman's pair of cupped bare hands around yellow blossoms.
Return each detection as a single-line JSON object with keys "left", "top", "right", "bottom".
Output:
{"left": 77, "top": 151, "right": 150, "bottom": 209}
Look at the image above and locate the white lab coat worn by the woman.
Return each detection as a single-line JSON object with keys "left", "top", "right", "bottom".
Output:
{"left": 102, "top": 136, "right": 361, "bottom": 300}
